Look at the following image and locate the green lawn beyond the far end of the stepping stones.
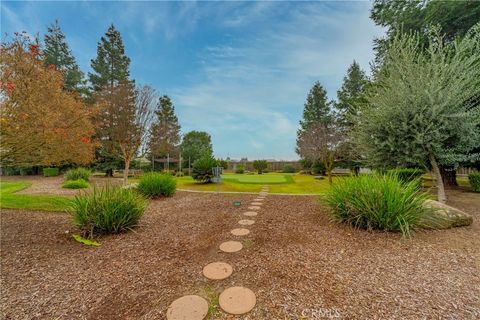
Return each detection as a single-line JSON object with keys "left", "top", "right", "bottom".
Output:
{"left": 177, "top": 173, "right": 335, "bottom": 194}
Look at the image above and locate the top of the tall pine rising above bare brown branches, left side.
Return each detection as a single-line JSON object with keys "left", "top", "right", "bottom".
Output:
{"left": 88, "top": 24, "right": 130, "bottom": 92}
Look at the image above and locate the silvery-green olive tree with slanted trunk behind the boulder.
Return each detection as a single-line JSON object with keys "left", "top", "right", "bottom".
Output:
{"left": 353, "top": 24, "right": 480, "bottom": 202}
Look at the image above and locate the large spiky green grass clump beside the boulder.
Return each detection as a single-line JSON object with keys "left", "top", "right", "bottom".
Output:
{"left": 324, "top": 174, "right": 430, "bottom": 236}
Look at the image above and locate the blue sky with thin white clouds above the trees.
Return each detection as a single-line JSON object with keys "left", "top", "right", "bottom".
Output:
{"left": 1, "top": 1, "right": 383, "bottom": 159}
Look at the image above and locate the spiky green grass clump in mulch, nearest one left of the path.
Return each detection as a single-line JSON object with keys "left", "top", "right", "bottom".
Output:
{"left": 69, "top": 186, "right": 147, "bottom": 236}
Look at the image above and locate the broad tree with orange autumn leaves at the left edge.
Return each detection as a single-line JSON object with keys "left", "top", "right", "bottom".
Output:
{"left": 0, "top": 34, "right": 95, "bottom": 167}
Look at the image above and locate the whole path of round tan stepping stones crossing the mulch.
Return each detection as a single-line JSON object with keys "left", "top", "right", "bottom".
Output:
{"left": 167, "top": 186, "right": 268, "bottom": 320}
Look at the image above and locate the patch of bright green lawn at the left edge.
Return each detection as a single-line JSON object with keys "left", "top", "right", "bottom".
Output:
{"left": 0, "top": 181, "right": 71, "bottom": 211}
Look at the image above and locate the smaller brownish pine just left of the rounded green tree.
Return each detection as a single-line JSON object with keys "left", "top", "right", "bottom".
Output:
{"left": 148, "top": 95, "right": 181, "bottom": 158}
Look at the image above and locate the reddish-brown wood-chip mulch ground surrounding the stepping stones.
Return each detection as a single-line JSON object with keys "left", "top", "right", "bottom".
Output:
{"left": 0, "top": 191, "right": 480, "bottom": 319}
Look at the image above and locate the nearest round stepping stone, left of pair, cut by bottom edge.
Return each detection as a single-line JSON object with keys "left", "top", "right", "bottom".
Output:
{"left": 167, "top": 295, "right": 208, "bottom": 320}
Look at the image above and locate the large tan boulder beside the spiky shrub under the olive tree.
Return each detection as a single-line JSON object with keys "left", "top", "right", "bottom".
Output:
{"left": 420, "top": 200, "right": 473, "bottom": 229}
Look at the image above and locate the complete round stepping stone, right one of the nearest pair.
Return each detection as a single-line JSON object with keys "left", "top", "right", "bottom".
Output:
{"left": 218, "top": 287, "right": 257, "bottom": 315}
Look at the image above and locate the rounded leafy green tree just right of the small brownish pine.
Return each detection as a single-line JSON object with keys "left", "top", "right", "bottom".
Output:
{"left": 181, "top": 131, "right": 213, "bottom": 167}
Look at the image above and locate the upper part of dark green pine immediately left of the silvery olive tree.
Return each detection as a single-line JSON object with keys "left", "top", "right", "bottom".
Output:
{"left": 335, "top": 60, "right": 368, "bottom": 130}
